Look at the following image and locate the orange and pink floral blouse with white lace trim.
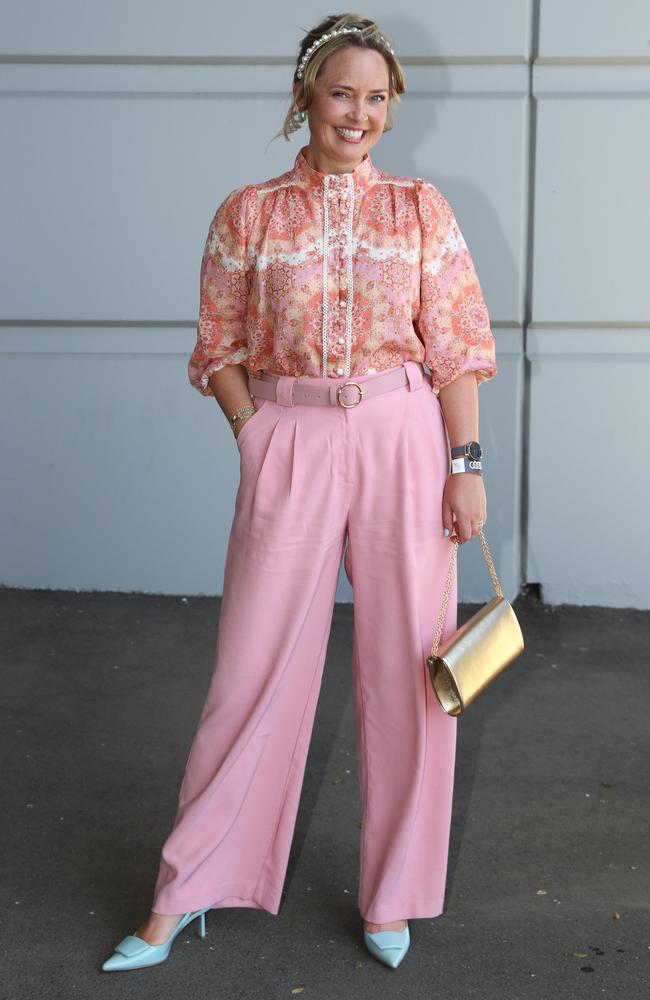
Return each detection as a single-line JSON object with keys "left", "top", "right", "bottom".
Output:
{"left": 188, "top": 146, "right": 497, "bottom": 396}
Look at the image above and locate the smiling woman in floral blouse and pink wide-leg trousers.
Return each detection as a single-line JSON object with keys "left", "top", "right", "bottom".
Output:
{"left": 103, "top": 14, "right": 497, "bottom": 970}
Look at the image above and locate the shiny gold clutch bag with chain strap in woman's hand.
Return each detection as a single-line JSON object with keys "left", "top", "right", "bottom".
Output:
{"left": 427, "top": 527, "right": 524, "bottom": 715}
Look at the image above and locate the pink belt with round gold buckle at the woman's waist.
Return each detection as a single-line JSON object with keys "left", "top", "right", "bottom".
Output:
{"left": 248, "top": 361, "right": 430, "bottom": 409}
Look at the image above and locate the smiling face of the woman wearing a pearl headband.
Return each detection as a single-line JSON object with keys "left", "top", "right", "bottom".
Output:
{"left": 294, "top": 46, "right": 389, "bottom": 173}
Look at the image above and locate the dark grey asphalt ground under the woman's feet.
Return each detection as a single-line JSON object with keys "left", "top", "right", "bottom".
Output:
{"left": 0, "top": 589, "right": 650, "bottom": 1000}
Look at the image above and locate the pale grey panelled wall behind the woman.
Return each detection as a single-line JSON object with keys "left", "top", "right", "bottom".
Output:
{"left": 0, "top": 0, "right": 650, "bottom": 607}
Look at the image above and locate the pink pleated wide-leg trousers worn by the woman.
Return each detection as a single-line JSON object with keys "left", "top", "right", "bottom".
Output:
{"left": 152, "top": 361, "right": 457, "bottom": 923}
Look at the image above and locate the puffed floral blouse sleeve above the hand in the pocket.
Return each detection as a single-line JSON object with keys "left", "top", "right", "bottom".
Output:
{"left": 187, "top": 185, "right": 254, "bottom": 396}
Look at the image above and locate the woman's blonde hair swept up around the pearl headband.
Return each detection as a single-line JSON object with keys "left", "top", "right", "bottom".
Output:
{"left": 274, "top": 14, "right": 406, "bottom": 142}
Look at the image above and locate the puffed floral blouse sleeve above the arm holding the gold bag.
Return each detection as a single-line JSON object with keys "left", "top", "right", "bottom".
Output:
{"left": 414, "top": 178, "right": 497, "bottom": 393}
